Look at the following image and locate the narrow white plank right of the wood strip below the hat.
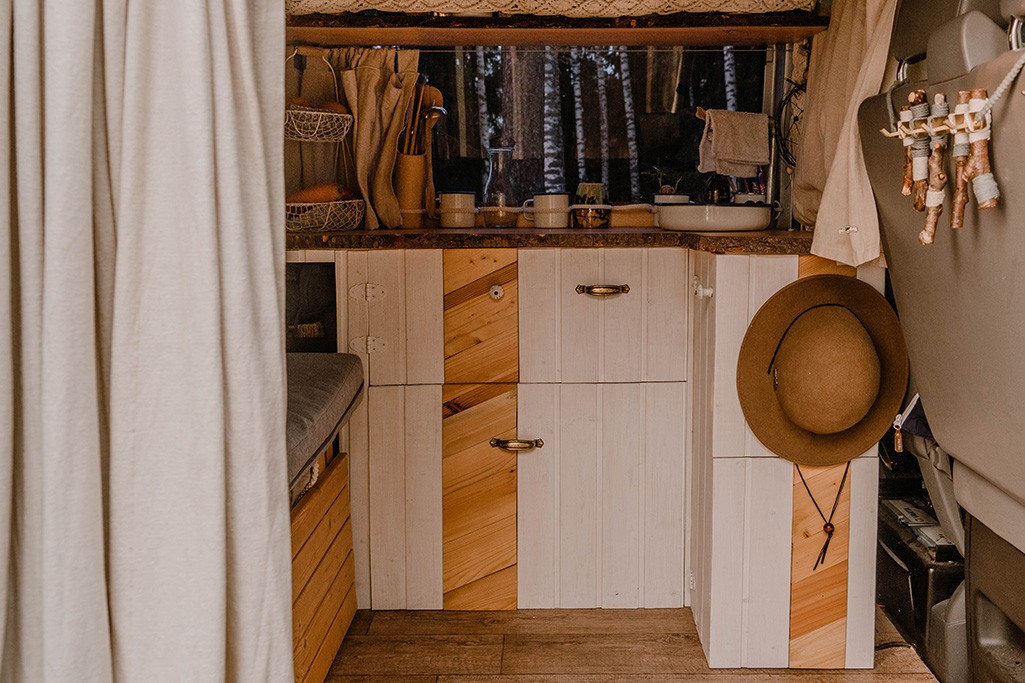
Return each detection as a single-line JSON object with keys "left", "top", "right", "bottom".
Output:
{"left": 846, "top": 448, "right": 879, "bottom": 669}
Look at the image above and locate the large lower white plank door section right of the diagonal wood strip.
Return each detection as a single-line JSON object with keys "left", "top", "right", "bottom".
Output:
{"left": 517, "top": 383, "right": 688, "bottom": 608}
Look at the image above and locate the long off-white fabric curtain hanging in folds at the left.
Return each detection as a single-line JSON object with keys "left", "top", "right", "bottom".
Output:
{"left": 0, "top": 0, "right": 292, "bottom": 681}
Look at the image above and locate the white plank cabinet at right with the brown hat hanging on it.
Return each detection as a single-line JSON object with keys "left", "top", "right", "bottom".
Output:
{"left": 690, "top": 251, "right": 877, "bottom": 668}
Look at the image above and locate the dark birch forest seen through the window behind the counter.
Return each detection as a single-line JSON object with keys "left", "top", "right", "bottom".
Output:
{"left": 419, "top": 47, "right": 766, "bottom": 202}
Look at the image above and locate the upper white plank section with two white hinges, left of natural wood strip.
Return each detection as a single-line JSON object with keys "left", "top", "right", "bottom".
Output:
{"left": 335, "top": 249, "right": 445, "bottom": 387}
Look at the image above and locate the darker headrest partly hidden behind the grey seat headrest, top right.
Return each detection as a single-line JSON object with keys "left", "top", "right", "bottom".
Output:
{"left": 890, "top": 0, "right": 1004, "bottom": 62}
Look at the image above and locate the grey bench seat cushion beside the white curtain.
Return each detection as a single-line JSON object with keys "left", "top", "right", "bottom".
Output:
{"left": 287, "top": 354, "right": 363, "bottom": 485}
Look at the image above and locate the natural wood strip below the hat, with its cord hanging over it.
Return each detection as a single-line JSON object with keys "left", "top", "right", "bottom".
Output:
{"left": 789, "top": 465, "right": 851, "bottom": 669}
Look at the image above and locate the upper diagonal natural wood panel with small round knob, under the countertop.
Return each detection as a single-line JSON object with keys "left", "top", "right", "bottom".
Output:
{"left": 444, "top": 249, "right": 520, "bottom": 384}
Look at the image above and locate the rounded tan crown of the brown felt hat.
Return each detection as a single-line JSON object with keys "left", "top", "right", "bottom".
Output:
{"left": 771, "top": 305, "right": 880, "bottom": 435}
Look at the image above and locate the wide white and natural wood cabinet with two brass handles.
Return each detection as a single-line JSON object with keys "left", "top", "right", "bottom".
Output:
{"left": 305, "top": 248, "right": 689, "bottom": 609}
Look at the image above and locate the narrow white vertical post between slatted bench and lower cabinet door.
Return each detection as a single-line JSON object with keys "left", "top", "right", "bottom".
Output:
{"left": 345, "top": 389, "right": 371, "bottom": 609}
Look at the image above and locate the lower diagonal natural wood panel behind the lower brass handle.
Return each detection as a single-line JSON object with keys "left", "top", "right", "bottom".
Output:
{"left": 442, "top": 385, "right": 517, "bottom": 609}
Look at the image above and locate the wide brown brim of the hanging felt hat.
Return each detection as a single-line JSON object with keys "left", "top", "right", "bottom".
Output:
{"left": 737, "top": 275, "right": 908, "bottom": 467}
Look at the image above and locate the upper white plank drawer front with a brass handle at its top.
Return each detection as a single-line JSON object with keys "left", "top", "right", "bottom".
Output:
{"left": 519, "top": 248, "right": 689, "bottom": 384}
